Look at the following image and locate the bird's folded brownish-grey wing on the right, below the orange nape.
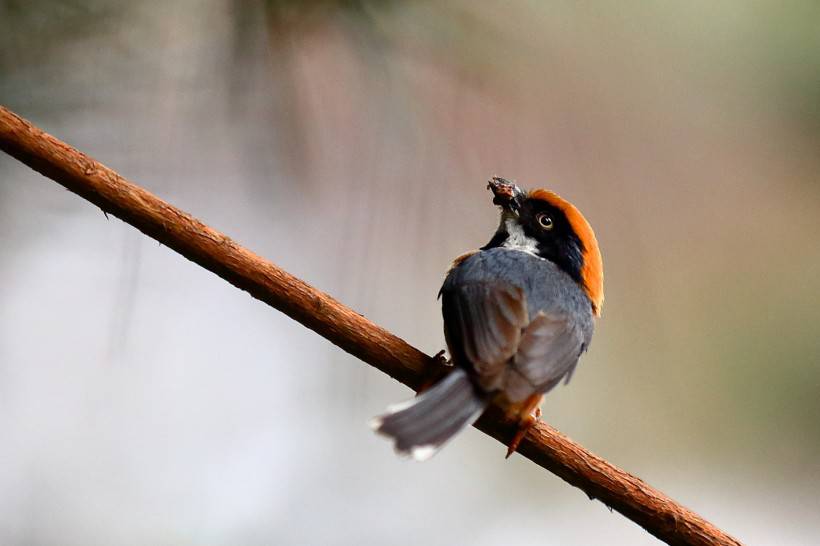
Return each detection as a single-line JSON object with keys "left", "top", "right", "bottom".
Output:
{"left": 502, "top": 311, "right": 585, "bottom": 402}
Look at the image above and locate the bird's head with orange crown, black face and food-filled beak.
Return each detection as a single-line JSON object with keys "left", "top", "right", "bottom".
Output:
{"left": 483, "top": 177, "right": 604, "bottom": 316}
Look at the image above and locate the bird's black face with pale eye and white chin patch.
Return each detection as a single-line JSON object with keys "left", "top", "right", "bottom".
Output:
{"left": 482, "top": 198, "right": 584, "bottom": 282}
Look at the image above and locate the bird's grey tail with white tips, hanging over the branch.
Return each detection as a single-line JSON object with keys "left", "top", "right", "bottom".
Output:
{"left": 372, "top": 369, "right": 488, "bottom": 461}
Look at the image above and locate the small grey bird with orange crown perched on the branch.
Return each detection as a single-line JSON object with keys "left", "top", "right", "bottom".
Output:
{"left": 372, "top": 177, "right": 604, "bottom": 460}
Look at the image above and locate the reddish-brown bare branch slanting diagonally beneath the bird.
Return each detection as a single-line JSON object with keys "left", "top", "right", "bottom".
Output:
{"left": 0, "top": 106, "right": 740, "bottom": 545}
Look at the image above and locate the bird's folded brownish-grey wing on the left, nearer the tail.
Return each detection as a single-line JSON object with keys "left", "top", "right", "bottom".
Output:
{"left": 441, "top": 282, "right": 529, "bottom": 391}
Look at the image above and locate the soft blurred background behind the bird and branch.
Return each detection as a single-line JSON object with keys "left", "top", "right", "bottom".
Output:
{"left": 0, "top": 0, "right": 820, "bottom": 546}
